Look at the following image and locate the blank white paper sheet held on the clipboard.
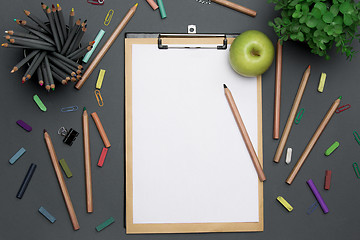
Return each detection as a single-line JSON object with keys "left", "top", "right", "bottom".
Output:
{"left": 132, "top": 44, "right": 259, "bottom": 224}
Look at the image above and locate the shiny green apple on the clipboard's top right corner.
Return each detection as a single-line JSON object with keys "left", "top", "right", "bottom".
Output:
{"left": 230, "top": 30, "right": 274, "bottom": 77}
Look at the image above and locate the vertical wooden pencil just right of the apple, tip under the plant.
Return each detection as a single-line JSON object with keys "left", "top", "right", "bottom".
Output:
{"left": 273, "top": 39, "right": 282, "bottom": 139}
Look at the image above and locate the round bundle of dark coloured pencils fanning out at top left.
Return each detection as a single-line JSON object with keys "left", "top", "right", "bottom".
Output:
{"left": 1, "top": 3, "right": 94, "bottom": 91}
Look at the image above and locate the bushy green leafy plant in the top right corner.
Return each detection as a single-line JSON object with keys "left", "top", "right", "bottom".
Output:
{"left": 268, "top": 0, "right": 360, "bottom": 60}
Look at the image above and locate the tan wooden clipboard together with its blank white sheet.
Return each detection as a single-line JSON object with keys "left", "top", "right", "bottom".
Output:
{"left": 125, "top": 33, "right": 264, "bottom": 234}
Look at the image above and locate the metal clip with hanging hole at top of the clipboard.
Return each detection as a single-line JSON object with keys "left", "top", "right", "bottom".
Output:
{"left": 158, "top": 25, "right": 227, "bottom": 50}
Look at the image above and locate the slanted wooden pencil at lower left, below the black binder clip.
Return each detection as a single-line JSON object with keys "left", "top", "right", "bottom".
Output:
{"left": 44, "top": 129, "right": 80, "bottom": 230}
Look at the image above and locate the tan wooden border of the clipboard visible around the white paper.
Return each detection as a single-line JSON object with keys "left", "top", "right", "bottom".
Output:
{"left": 125, "top": 38, "right": 264, "bottom": 234}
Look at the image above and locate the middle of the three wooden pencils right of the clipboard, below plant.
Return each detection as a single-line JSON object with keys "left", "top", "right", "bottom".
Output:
{"left": 274, "top": 65, "right": 311, "bottom": 163}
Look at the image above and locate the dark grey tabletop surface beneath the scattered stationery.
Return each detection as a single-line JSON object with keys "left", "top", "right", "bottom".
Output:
{"left": 0, "top": 0, "right": 360, "bottom": 240}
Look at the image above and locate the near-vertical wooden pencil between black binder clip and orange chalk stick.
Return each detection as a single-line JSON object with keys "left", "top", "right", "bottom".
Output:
{"left": 82, "top": 107, "right": 93, "bottom": 213}
